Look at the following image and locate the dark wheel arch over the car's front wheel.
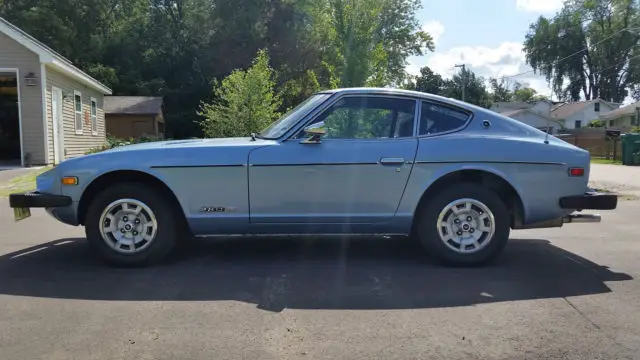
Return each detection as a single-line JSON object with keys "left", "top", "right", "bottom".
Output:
{"left": 78, "top": 170, "right": 186, "bottom": 225}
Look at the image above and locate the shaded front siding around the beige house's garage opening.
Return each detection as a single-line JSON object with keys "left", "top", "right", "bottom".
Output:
{"left": 0, "top": 33, "right": 47, "bottom": 165}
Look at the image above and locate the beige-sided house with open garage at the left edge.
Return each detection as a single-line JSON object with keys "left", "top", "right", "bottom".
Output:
{"left": 0, "top": 18, "right": 111, "bottom": 166}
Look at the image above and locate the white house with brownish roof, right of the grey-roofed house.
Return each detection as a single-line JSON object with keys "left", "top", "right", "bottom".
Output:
{"left": 551, "top": 99, "right": 620, "bottom": 129}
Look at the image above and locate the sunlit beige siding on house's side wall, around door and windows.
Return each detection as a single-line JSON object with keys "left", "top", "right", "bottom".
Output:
{"left": 45, "top": 67, "right": 106, "bottom": 163}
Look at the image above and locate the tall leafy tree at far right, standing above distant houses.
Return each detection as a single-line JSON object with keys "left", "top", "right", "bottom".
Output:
{"left": 524, "top": 0, "right": 640, "bottom": 102}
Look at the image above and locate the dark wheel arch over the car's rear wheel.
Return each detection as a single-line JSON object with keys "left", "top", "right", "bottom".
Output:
{"left": 413, "top": 168, "right": 525, "bottom": 228}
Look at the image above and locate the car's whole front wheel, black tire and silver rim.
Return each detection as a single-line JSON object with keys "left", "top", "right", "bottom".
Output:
{"left": 85, "top": 183, "right": 181, "bottom": 265}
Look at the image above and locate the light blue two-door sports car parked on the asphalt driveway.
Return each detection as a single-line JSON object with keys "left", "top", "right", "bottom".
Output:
{"left": 10, "top": 88, "right": 617, "bottom": 265}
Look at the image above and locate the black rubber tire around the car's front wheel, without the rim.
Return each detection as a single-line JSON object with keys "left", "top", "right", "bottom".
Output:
{"left": 85, "top": 182, "right": 183, "bottom": 266}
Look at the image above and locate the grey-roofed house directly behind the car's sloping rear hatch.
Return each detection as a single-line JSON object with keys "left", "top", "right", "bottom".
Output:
{"left": 491, "top": 100, "right": 563, "bottom": 134}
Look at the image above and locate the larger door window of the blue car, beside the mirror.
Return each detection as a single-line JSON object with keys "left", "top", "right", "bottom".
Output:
{"left": 298, "top": 96, "right": 416, "bottom": 139}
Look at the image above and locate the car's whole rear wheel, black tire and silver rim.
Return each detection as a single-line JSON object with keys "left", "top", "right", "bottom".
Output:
{"left": 415, "top": 183, "right": 510, "bottom": 266}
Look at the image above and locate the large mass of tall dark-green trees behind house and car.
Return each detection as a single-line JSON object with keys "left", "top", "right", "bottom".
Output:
{"left": 0, "top": 0, "right": 433, "bottom": 138}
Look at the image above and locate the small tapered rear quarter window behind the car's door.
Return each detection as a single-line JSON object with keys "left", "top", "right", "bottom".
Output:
{"left": 418, "top": 102, "right": 469, "bottom": 135}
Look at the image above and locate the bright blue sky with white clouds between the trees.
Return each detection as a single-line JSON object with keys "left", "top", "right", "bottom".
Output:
{"left": 407, "top": 0, "right": 563, "bottom": 96}
